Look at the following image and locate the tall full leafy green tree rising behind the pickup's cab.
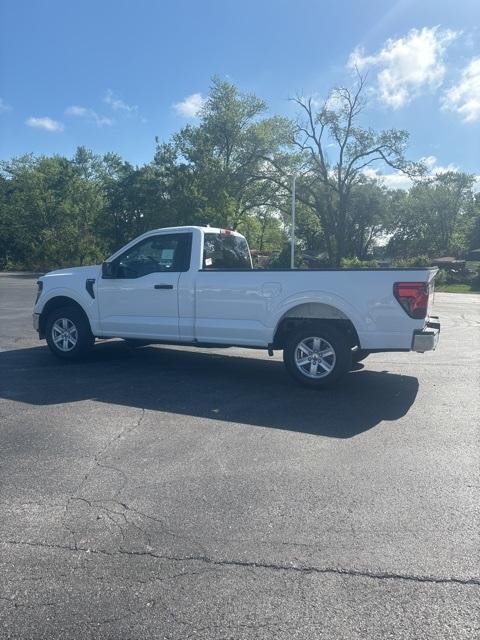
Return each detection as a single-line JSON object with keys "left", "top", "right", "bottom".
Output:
{"left": 155, "top": 78, "right": 289, "bottom": 229}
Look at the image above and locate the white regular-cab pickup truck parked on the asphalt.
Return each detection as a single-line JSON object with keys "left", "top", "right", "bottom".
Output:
{"left": 33, "top": 227, "right": 440, "bottom": 387}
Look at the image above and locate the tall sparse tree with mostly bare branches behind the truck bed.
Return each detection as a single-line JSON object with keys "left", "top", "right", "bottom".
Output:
{"left": 288, "top": 76, "right": 423, "bottom": 266}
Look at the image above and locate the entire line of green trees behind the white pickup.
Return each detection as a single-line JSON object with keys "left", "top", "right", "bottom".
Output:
{"left": 0, "top": 76, "right": 480, "bottom": 270}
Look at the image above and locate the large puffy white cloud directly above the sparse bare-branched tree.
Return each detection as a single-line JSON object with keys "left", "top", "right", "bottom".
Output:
{"left": 348, "top": 27, "right": 459, "bottom": 109}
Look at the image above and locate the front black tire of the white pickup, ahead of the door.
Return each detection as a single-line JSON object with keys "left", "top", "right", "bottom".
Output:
{"left": 45, "top": 305, "right": 95, "bottom": 360}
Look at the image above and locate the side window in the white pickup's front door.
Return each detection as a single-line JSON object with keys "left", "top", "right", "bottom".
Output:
{"left": 113, "top": 233, "right": 192, "bottom": 278}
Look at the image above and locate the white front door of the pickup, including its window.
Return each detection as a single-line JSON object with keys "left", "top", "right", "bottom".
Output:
{"left": 98, "top": 233, "right": 191, "bottom": 340}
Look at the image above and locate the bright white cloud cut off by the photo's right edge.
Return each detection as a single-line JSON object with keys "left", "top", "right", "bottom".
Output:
{"left": 443, "top": 57, "right": 480, "bottom": 122}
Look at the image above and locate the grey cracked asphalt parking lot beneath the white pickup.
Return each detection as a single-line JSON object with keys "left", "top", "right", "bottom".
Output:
{"left": 0, "top": 275, "right": 480, "bottom": 640}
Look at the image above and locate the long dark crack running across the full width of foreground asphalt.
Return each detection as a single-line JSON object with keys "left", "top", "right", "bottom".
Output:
{"left": 0, "top": 540, "right": 480, "bottom": 586}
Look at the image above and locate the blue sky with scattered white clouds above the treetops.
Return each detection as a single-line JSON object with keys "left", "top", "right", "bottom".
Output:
{"left": 0, "top": 0, "right": 480, "bottom": 184}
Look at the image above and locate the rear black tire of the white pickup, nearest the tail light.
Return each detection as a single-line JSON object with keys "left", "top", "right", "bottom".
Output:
{"left": 283, "top": 323, "right": 352, "bottom": 389}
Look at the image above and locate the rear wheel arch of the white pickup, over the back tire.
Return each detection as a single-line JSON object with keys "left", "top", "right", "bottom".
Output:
{"left": 272, "top": 302, "right": 360, "bottom": 349}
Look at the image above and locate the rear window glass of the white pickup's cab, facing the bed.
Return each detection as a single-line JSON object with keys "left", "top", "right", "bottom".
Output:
{"left": 203, "top": 233, "right": 252, "bottom": 269}
